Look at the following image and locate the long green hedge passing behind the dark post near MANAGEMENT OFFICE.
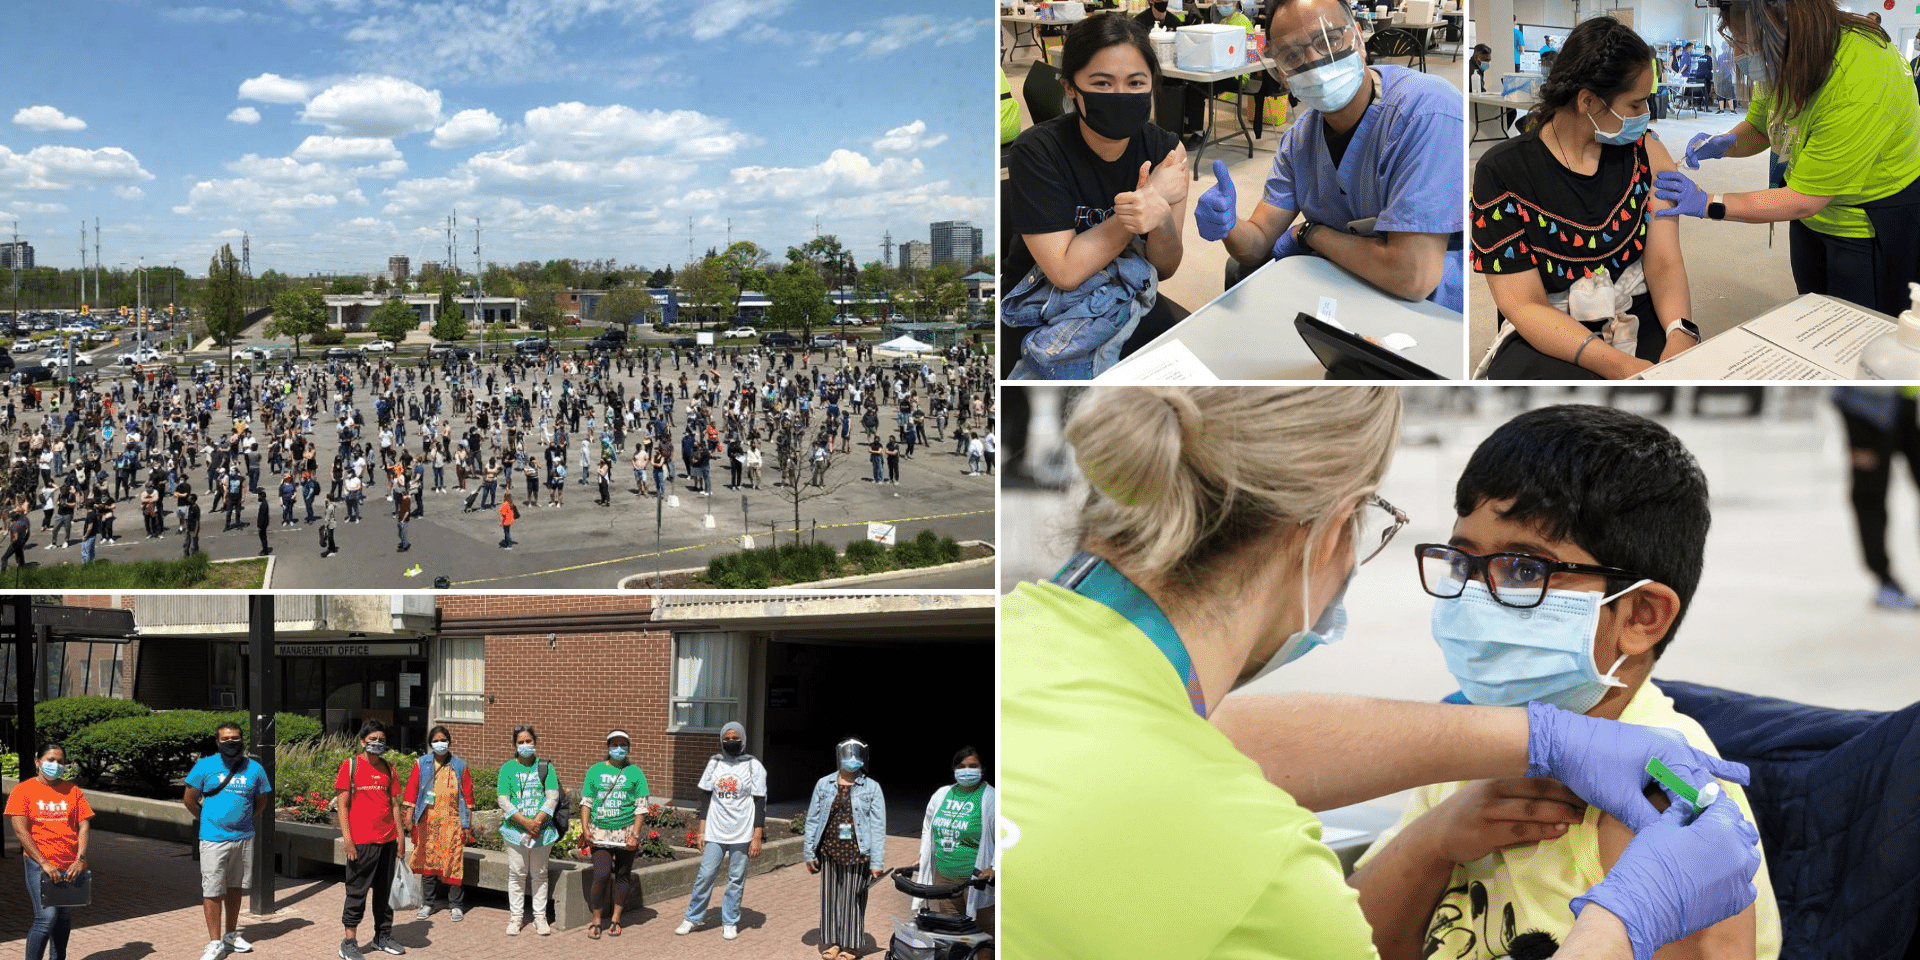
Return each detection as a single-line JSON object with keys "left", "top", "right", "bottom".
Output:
{"left": 67, "top": 710, "right": 321, "bottom": 797}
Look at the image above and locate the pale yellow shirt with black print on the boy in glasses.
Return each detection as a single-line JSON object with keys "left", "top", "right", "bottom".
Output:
{"left": 1356, "top": 682, "right": 1780, "bottom": 960}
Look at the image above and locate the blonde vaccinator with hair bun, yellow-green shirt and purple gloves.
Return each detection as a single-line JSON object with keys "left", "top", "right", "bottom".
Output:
{"left": 998, "top": 386, "right": 1761, "bottom": 960}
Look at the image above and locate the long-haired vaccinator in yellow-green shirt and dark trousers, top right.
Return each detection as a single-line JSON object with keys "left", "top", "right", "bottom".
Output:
{"left": 1655, "top": 0, "right": 1920, "bottom": 315}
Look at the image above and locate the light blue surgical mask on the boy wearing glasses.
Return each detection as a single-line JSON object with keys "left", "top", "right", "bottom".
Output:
{"left": 1432, "top": 580, "right": 1651, "bottom": 714}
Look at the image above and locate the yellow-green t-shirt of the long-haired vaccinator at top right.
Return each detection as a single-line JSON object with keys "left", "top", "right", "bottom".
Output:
{"left": 1747, "top": 29, "right": 1920, "bottom": 238}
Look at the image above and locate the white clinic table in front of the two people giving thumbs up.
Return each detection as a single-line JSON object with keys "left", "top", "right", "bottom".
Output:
{"left": 1105, "top": 250, "right": 1467, "bottom": 380}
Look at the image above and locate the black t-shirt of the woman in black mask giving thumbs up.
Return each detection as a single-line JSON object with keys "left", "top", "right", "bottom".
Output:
{"left": 1000, "top": 113, "right": 1179, "bottom": 282}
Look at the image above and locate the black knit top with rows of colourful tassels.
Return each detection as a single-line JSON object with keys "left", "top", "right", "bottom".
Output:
{"left": 1471, "top": 129, "right": 1653, "bottom": 294}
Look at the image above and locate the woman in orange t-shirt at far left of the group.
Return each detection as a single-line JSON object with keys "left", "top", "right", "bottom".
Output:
{"left": 6, "top": 743, "right": 94, "bottom": 960}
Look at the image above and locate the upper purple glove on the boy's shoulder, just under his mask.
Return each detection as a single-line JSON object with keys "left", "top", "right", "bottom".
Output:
{"left": 1526, "top": 701, "right": 1751, "bottom": 833}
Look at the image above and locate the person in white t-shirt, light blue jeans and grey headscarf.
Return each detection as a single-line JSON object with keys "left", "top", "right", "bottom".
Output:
{"left": 674, "top": 720, "right": 766, "bottom": 941}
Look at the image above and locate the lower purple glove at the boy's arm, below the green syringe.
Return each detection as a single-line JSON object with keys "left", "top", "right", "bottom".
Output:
{"left": 1569, "top": 799, "right": 1761, "bottom": 960}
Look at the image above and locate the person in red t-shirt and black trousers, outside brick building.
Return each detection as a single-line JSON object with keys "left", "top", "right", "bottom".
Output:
{"left": 334, "top": 721, "right": 407, "bottom": 960}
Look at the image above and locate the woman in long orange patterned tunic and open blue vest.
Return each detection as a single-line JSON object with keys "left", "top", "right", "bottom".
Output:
{"left": 403, "top": 724, "right": 474, "bottom": 921}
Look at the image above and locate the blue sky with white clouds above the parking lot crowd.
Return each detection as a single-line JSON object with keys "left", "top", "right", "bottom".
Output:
{"left": 0, "top": 0, "right": 995, "bottom": 275}
